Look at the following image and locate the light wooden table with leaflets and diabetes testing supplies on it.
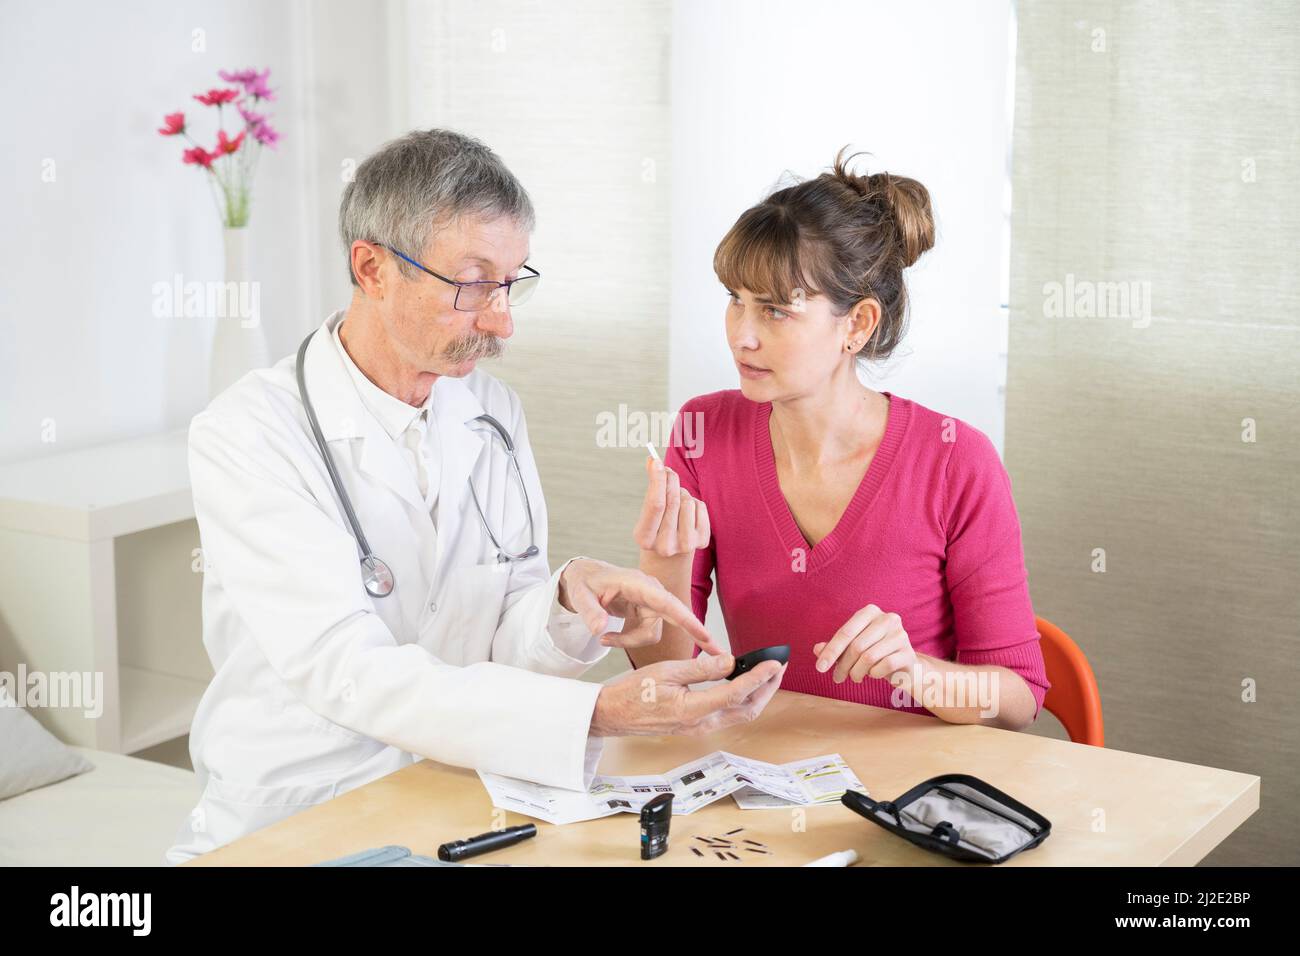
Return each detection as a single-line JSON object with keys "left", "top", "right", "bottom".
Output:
{"left": 189, "top": 691, "right": 1260, "bottom": 866}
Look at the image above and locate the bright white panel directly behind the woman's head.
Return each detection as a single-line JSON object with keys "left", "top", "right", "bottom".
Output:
{"left": 670, "top": 0, "right": 1011, "bottom": 449}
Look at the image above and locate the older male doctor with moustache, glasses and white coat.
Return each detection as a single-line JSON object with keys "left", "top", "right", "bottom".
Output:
{"left": 166, "top": 130, "right": 783, "bottom": 864}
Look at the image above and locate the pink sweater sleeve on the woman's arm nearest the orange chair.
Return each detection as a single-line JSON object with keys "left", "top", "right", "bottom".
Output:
{"left": 943, "top": 423, "right": 1050, "bottom": 719}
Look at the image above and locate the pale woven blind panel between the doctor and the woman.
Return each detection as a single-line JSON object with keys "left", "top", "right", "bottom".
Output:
{"left": 394, "top": 0, "right": 671, "bottom": 676}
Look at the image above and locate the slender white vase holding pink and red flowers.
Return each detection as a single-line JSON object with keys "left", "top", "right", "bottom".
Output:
{"left": 208, "top": 228, "right": 270, "bottom": 398}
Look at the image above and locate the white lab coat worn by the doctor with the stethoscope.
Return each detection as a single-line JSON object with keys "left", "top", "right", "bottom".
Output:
{"left": 166, "top": 311, "right": 607, "bottom": 864}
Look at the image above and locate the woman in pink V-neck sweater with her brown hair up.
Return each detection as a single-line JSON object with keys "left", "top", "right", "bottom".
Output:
{"left": 632, "top": 151, "right": 1049, "bottom": 730}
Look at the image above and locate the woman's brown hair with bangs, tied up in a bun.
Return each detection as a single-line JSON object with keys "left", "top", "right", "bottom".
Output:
{"left": 714, "top": 147, "right": 935, "bottom": 358}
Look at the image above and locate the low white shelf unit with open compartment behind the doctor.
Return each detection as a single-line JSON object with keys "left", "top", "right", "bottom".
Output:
{"left": 0, "top": 429, "right": 211, "bottom": 753}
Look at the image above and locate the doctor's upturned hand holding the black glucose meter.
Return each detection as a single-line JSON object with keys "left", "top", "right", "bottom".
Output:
{"left": 590, "top": 654, "right": 787, "bottom": 737}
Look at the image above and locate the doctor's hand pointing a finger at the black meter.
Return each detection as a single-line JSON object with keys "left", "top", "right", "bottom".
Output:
{"left": 558, "top": 558, "right": 725, "bottom": 658}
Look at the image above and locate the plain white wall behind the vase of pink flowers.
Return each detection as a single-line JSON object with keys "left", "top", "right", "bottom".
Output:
{"left": 0, "top": 0, "right": 393, "bottom": 462}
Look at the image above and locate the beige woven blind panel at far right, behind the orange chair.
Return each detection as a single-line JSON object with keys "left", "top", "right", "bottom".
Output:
{"left": 1006, "top": 0, "right": 1300, "bottom": 864}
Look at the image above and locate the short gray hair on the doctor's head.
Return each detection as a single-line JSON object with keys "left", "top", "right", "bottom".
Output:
{"left": 338, "top": 130, "right": 534, "bottom": 285}
